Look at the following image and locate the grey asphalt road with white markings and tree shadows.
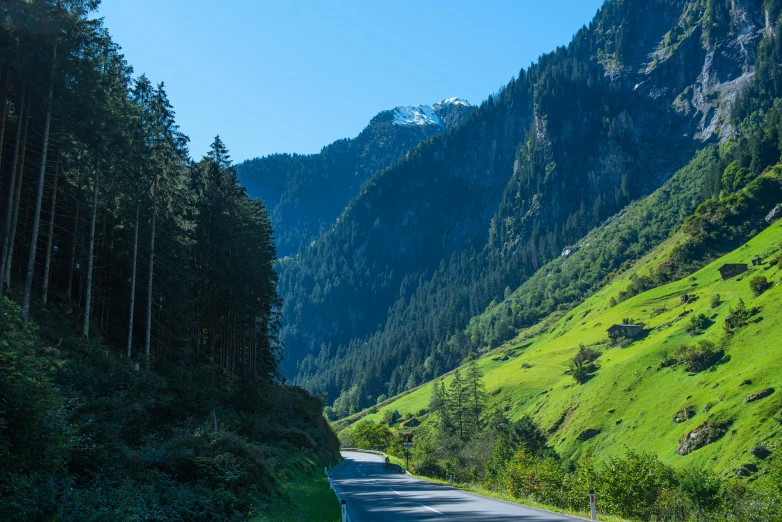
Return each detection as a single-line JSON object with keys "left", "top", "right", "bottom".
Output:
{"left": 331, "top": 452, "right": 582, "bottom": 522}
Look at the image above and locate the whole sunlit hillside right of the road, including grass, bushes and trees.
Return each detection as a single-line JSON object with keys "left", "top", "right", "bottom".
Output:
{"left": 337, "top": 170, "right": 782, "bottom": 521}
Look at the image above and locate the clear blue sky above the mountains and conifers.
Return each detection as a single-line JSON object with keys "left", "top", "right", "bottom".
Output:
{"left": 99, "top": 0, "right": 602, "bottom": 161}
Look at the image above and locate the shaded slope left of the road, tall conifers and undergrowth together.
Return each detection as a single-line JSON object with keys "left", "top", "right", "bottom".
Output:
{"left": 0, "top": 0, "right": 338, "bottom": 521}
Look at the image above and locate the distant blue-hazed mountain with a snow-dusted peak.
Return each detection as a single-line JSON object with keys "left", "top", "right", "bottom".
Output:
{"left": 236, "top": 98, "right": 474, "bottom": 257}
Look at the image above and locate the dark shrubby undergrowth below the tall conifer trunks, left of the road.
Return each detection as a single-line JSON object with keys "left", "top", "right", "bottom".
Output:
{"left": 0, "top": 298, "right": 338, "bottom": 521}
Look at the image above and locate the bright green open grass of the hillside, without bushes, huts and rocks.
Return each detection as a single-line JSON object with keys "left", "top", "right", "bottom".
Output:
{"left": 348, "top": 212, "right": 782, "bottom": 473}
